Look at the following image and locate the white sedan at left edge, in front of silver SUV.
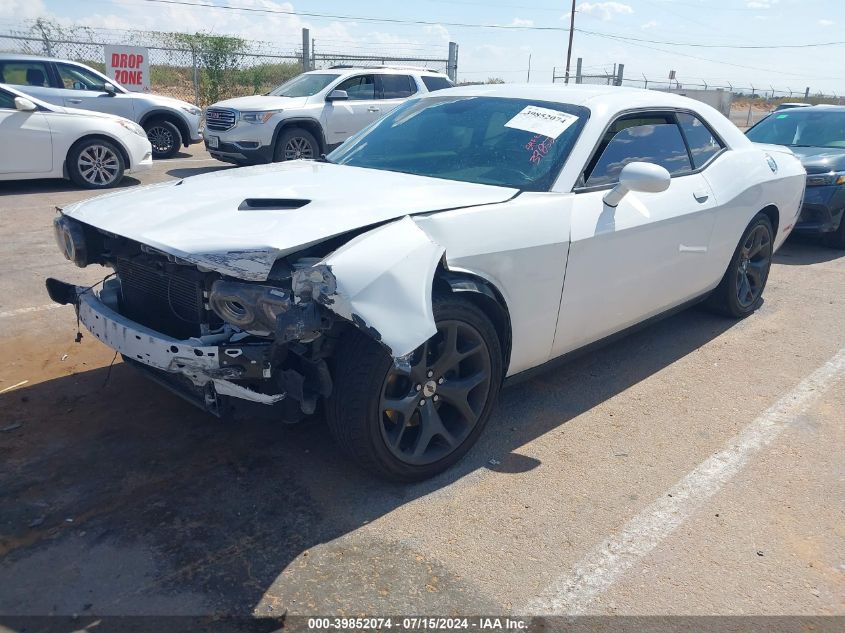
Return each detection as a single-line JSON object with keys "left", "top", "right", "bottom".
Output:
{"left": 0, "top": 84, "right": 153, "bottom": 189}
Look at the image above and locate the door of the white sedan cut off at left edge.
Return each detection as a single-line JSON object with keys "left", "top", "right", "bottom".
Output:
{"left": 0, "top": 90, "right": 53, "bottom": 174}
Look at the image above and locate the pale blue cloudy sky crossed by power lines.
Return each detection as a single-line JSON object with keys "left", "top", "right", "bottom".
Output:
{"left": 0, "top": 0, "right": 845, "bottom": 95}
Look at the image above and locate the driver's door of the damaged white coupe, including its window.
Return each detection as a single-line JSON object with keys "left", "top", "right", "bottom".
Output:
{"left": 553, "top": 112, "right": 717, "bottom": 356}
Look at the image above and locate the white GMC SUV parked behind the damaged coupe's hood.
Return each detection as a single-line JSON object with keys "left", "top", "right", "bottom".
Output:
{"left": 205, "top": 66, "right": 452, "bottom": 165}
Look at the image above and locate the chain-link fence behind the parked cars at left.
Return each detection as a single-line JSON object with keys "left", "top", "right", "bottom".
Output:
{"left": 0, "top": 21, "right": 448, "bottom": 107}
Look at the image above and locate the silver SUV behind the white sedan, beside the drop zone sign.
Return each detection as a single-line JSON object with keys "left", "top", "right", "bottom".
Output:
{"left": 0, "top": 53, "right": 202, "bottom": 158}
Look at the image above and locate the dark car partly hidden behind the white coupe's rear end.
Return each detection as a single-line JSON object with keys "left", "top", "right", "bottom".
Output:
{"left": 746, "top": 105, "right": 845, "bottom": 249}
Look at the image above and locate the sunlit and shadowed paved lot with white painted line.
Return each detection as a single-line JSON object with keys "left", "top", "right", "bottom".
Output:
{"left": 0, "top": 142, "right": 845, "bottom": 616}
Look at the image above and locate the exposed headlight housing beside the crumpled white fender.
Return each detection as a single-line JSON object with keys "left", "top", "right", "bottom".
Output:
{"left": 208, "top": 279, "right": 292, "bottom": 336}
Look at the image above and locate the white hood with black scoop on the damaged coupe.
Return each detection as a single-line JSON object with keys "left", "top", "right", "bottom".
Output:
{"left": 62, "top": 161, "right": 518, "bottom": 281}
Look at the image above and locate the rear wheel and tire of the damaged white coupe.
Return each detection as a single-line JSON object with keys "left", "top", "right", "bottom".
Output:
{"left": 707, "top": 213, "right": 774, "bottom": 319}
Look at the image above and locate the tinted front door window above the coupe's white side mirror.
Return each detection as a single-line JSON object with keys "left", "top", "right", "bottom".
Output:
{"left": 584, "top": 114, "right": 692, "bottom": 187}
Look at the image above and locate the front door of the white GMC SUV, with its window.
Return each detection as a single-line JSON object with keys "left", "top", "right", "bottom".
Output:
{"left": 323, "top": 75, "right": 381, "bottom": 145}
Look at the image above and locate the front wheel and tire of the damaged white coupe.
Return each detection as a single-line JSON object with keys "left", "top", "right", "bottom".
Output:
{"left": 326, "top": 296, "right": 502, "bottom": 482}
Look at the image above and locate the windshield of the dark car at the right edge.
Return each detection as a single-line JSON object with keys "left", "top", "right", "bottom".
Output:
{"left": 747, "top": 108, "right": 845, "bottom": 147}
